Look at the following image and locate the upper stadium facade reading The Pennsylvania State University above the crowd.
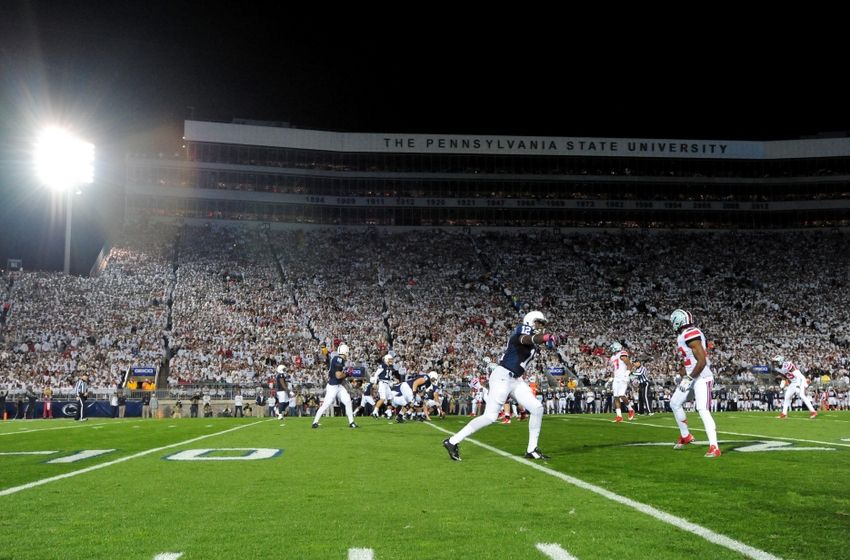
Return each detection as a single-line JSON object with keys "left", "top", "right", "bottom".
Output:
{"left": 125, "top": 121, "right": 850, "bottom": 229}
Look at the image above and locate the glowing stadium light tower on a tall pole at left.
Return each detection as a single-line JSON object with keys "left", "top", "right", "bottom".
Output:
{"left": 33, "top": 127, "right": 94, "bottom": 274}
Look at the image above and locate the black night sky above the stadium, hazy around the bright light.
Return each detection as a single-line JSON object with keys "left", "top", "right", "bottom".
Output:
{"left": 0, "top": 0, "right": 850, "bottom": 272}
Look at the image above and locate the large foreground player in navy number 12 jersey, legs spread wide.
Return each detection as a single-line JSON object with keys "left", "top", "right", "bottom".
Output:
{"left": 443, "top": 311, "right": 559, "bottom": 461}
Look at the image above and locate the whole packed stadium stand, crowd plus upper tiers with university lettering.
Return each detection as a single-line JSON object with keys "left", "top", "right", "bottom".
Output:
{"left": 0, "top": 121, "right": 850, "bottom": 414}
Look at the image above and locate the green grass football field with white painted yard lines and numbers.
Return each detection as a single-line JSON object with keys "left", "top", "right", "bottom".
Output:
{"left": 0, "top": 412, "right": 850, "bottom": 560}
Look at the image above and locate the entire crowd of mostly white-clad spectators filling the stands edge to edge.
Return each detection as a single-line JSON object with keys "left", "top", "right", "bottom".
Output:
{"left": 0, "top": 224, "right": 850, "bottom": 406}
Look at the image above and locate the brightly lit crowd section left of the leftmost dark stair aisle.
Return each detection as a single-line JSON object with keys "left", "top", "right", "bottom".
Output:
{"left": 0, "top": 228, "right": 171, "bottom": 396}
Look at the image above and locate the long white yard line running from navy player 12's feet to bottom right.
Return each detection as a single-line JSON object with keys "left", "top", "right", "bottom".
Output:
{"left": 428, "top": 423, "right": 779, "bottom": 560}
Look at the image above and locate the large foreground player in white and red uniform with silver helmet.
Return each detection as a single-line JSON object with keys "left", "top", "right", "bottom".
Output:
{"left": 670, "top": 309, "right": 720, "bottom": 457}
